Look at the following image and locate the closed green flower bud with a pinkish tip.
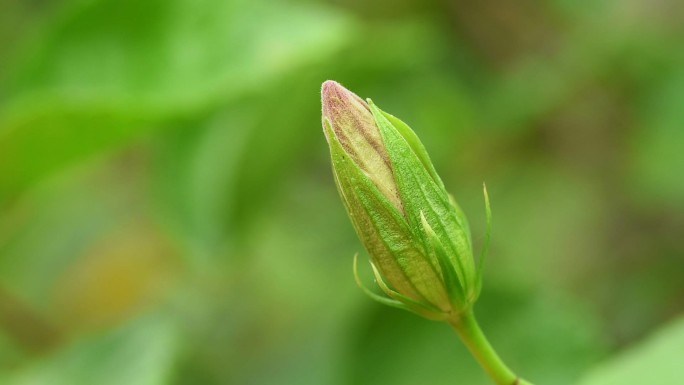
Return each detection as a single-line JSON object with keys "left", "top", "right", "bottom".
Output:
{"left": 321, "top": 80, "right": 489, "bottom": 319}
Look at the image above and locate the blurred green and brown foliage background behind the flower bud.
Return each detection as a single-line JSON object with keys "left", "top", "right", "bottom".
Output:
{"left": 0, "top": 0, "right": 684, "bottom": 385}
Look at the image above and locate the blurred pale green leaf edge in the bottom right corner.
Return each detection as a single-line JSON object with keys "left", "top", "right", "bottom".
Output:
{"left": 580, "top": 318, "right": 684, "bottom": 385}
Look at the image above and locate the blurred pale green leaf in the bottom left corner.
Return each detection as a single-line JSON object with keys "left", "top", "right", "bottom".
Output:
{"left": 0, "top": 315, "right": 178, "bottom": 385}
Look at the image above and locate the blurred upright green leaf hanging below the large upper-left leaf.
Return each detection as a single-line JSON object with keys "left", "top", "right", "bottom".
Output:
{"left": 150, "top": 104, "right": 258, "bottom": 269}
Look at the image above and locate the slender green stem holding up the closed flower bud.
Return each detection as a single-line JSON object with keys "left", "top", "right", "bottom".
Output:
{"left": 449, "top": 310, "right": 532, "bottom": 385}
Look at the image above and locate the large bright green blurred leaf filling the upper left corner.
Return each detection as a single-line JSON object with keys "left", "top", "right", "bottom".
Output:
{"left": 0, "top": 0, "right": 352, "bottom": 198}
